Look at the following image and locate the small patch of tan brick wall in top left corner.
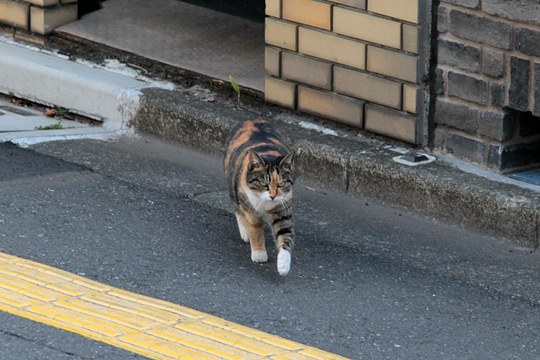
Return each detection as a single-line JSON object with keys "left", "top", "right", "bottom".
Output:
{"left": 0, "top": 0, "right": 77, "bottom": 35}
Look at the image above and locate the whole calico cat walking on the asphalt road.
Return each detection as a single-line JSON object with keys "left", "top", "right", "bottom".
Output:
{"left": 224, "top": 120, "right": 294, "bottom": 276}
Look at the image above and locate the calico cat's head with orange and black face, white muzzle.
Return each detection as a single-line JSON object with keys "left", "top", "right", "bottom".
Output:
{"left": 247, "top": 151, "right": 294, "bottom": 203}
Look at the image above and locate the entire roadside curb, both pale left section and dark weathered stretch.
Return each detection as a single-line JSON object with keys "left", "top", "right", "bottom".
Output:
{"left": 0, "top": 28, "right": 540, "bottom": 249}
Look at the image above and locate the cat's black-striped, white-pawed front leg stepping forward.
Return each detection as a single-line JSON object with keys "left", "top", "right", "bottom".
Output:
{"left": 271, "top": 214, "right": 294, "bottom": 276}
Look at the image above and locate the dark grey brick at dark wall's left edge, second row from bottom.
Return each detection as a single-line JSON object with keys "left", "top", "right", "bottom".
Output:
{"left": 435, "top": 98, "right": 479, "bottom": 134}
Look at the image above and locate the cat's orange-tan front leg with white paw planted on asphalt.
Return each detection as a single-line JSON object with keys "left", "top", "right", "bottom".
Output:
{"left": 236, "top": 209, "right": 268, "bottom": 262}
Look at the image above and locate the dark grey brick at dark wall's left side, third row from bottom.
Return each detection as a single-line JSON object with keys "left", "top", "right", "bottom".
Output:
{"left": 448, "top": 71, "right": 488, "bottom": 104}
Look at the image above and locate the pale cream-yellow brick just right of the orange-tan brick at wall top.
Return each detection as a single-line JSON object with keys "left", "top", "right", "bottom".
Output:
{"left": 333, "top": 6, "right": 401, "bottom": 49}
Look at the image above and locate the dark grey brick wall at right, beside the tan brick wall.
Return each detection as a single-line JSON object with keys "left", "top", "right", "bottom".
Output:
{"left": 434, "top": 0, "right": 540, "bottom": 171}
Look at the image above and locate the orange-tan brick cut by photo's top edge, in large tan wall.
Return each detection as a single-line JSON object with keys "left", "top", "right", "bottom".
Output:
{"left": 282, "top": 0, "right": 331, "bottom": 30}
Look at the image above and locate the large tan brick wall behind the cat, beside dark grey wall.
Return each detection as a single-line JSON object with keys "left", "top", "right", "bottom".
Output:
{"left": 265, "top": 0, "right": 421, "bottom": 143}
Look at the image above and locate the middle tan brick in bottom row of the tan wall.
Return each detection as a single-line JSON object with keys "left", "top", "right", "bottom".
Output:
{"left": 298, "top": 86, "right": 364, "bottom": 128}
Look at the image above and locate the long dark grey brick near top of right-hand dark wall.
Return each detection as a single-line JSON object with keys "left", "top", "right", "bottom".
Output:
{"left": 449, "top": 10, "right": 512, "bottom": 50}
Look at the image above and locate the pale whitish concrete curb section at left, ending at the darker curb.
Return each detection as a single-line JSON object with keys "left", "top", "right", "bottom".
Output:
{"left": 0, "top": 37, "right": 168, "bottom": 130}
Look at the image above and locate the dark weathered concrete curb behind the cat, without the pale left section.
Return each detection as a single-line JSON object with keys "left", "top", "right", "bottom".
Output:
{"left": 130, "top": 89, "right": 540, "bottom": 248}
